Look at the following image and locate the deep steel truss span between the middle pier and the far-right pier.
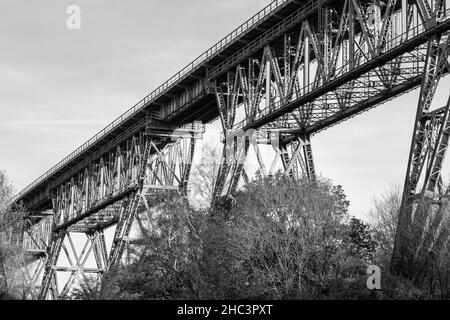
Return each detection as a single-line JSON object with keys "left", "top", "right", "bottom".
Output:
{"left": 208, "top": 0, "right": 450, "bottom": 134}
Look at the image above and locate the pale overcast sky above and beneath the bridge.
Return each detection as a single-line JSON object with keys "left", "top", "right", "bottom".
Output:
{"left": 0, "top": 0, "right": 449, "bottom": 217}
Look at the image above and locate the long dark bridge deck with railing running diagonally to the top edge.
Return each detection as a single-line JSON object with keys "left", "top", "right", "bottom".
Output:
{"left": 14, "top": 0, "right": 307, "bottom": 208}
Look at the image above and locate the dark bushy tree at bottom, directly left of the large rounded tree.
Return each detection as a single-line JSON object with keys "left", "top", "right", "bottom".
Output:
{"left": 74, "top": 195, "right": 206, "bottom": 300}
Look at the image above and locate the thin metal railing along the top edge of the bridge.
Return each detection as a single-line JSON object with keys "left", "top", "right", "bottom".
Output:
{"left": 13, "top": 0, "right": 294, "bottom": 202}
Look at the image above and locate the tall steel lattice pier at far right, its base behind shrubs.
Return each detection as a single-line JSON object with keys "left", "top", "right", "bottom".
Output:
{"left": 391, "top": 27, "right": 450, "bottom": 284}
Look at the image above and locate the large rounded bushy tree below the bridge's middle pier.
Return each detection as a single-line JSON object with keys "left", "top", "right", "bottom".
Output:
{"left": 199, "top": 175, "right": 365, "bottom": 299}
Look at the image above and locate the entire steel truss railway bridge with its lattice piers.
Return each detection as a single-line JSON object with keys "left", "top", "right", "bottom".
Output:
{"left": 5, "top": 0, "right": 450, "bottom": 299}
